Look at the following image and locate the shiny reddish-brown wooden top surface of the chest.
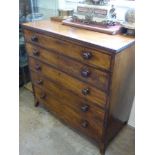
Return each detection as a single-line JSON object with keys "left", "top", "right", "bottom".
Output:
{"left": 23, "top": 20, "right": 134, "bottom": 53}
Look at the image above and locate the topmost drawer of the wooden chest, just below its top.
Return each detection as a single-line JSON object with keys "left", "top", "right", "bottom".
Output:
{"left": 24, "top": 30, "right": 111, "bottom": 70}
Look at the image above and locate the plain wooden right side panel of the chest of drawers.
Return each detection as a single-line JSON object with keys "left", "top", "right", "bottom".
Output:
{"left": 107, "top": 46, "right": 135, "bottom": 143}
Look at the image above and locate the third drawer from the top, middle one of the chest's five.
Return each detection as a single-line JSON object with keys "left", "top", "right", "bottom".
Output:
{"left": 29, "top": 57, "right": 106, "bottom": 107}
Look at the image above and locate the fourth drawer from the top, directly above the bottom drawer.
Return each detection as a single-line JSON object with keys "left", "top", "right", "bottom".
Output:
{"left": 31, "top": 71, "right": 105, "bottom": 125}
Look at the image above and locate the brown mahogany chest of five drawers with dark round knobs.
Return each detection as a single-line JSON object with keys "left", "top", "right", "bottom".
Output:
{"left": 23, "top": 21, "right": 135, "bottom": 154}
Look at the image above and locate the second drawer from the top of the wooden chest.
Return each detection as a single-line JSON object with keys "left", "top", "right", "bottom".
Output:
{"left": 26, "top": 43, "right": 109, "bottom": 91}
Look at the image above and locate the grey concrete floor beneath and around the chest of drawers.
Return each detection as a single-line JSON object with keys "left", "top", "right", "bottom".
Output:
{"left": 19, "top": 88, "right": 135, "bottom": 155}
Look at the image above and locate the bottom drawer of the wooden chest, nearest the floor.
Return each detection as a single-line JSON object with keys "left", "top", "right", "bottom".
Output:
{"left": 34, "top": 86, "right": 103, "bottom": 141}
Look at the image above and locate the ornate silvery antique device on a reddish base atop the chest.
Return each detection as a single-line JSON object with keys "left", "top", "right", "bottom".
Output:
{"left": 63, "top": 4, "right": 121, "bottom": 34}
